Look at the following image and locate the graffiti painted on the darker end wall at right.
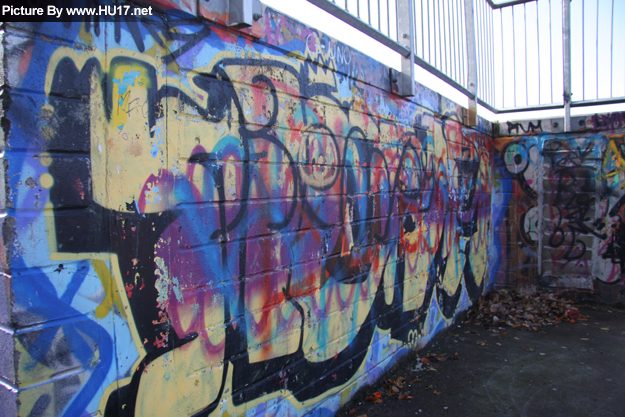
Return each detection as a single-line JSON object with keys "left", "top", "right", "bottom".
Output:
{"left": 498, "top": 134, "right": 625, "bottom": 288}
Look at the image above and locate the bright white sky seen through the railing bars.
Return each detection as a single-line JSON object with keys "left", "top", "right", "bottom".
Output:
{"left": 262, "top": 0, "right": 625, "bottom": 121}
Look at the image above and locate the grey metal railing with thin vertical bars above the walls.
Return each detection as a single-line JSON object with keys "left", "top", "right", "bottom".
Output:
{"left": 308, "top": 0, "right": 625, "bottom": 123}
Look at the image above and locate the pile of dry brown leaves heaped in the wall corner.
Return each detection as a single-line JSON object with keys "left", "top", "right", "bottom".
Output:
{"left": 467, "top": 290, "right": 588, "bottom": 330}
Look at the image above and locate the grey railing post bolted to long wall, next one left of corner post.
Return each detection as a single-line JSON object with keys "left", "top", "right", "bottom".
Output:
{"left": 397, "top": 0, "right": 415, "bottom": 97}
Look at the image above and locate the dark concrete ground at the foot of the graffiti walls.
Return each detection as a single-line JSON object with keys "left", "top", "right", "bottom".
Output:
{"left": 337, "top": 304, "right": 625, "bottom": 417}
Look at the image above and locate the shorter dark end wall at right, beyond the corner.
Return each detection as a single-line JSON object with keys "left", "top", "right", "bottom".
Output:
{"left": 493, "top": 113, "right": 625, "bottom": 302}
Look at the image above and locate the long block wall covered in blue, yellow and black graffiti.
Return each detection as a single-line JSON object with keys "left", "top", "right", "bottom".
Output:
{"left": 0, "top": 2, "right": 493, "bottom": 416}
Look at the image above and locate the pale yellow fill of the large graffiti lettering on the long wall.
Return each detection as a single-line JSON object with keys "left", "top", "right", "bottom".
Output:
{"left": 37, "top": 33, "right": 492, "bottom": 416}
